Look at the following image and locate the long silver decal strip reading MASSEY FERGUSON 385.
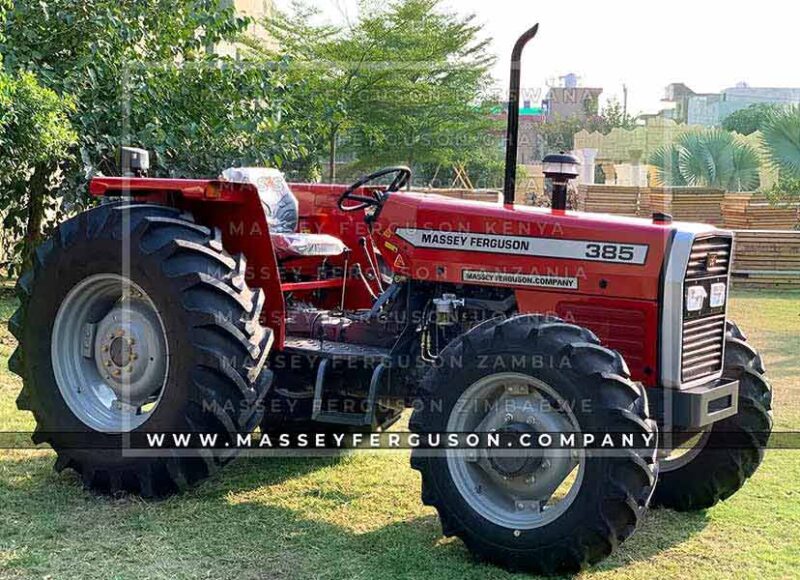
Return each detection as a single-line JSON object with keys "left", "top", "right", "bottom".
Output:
{"left": 395, "top": 228, "right": 648, "bottom": 264}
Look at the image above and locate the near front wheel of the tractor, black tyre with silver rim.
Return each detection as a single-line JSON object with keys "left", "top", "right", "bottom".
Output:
{"left": 410, "top": 315, "right": 656, "bottom": 574}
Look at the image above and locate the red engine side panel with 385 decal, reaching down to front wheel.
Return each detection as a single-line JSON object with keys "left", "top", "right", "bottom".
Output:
{"left": 376, "top": 194, "right": 672, "bottom": 386}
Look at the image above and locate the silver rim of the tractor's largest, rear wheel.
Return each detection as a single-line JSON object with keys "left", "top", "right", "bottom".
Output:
{"left": 50, "top": 274, "right": 169, "bottom": 433}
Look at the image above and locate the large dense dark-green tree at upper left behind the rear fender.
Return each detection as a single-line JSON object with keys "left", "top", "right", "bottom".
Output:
{"left": 0, "top": 0, "right": 318, "bottom": 201}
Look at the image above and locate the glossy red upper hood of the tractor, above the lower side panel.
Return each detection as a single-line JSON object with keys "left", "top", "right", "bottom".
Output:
{"left": 376, "top": 192, "right": 715, "bottom": 301}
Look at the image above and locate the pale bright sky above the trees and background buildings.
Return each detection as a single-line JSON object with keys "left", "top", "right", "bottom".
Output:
{"left": 275, "top": 0, "right": 800, "bottom": 114}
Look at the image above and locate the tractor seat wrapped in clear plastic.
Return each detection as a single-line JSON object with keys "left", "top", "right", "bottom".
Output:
{"left": 221, "top": 167, "right": 347, "bottom": 260}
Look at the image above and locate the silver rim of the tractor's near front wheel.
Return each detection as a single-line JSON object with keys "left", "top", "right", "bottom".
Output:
{"left": 446, "top": 373, "right": 585, "bottom": 530}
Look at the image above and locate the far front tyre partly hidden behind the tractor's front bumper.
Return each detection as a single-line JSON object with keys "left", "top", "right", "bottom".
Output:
{"left": 653, "top": 322, "right": 772, "bottom": 511}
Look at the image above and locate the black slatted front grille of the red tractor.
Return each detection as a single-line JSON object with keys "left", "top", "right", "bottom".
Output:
{"left": 681, "top": 235, "right": 731, "bottom": 382}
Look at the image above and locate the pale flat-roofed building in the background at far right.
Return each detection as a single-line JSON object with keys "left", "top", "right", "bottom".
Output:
{"left": 662, "top": 83, "right": 800, "bottom": 127}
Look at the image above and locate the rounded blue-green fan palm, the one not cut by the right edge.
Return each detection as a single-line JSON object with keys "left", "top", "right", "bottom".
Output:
{"left": 648, "top": 129, "right": 760, "bottom": 191}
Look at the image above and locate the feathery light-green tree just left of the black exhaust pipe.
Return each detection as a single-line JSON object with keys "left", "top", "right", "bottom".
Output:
{"left": 347, "top": 0, "right": 502, "bottom": 181}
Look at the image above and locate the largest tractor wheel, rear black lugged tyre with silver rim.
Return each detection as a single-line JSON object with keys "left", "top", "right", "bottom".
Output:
{"left": 9, "top": 202, "right": 272, "bottom": 496}
